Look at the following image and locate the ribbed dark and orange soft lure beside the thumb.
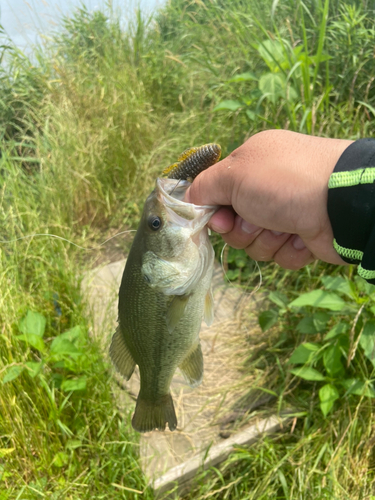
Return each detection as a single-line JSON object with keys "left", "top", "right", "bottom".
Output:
{"left": 163, "top": 143, "right": 221, "bottom": 182}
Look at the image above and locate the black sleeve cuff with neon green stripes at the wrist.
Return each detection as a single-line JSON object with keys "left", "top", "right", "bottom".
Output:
{"left": 328, "top": 139, "right": 375, "bottom": 284}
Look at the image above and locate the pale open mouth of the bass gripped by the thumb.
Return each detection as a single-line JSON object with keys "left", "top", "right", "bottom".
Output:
{"left": 156, "top": 178, "right": 219, "bottom": 235}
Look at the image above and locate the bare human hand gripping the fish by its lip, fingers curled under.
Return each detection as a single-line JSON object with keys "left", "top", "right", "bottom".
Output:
{"left": 187, "top": 130, "right": 353, "bottom": 269}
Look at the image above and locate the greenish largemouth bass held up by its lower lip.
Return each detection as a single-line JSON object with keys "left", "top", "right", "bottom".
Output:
{"left": 110, "top": 146, "right": 222, "bottom": 432}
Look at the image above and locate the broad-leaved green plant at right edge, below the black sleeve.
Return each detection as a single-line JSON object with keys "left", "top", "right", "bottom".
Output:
{"left": 259, "top": 276, "right": 375, "bottom": 416}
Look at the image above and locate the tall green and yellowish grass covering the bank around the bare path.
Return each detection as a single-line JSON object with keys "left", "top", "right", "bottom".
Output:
{"left": 0, "top": 0, "right": 375, "bottom": 500}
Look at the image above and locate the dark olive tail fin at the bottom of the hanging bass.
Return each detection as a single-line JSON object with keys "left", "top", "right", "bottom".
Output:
{"left": 132, "top": 393, "right": 177, "bottom": 432}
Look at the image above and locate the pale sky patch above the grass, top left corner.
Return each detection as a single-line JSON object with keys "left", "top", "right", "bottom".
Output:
{"left": 0, "top": 0, "right": 163, "bottom": 52}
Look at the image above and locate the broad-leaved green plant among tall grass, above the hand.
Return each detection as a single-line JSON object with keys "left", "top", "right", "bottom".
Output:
{"left": 214, "top": 0, "right": 330, "bottom": 133}
